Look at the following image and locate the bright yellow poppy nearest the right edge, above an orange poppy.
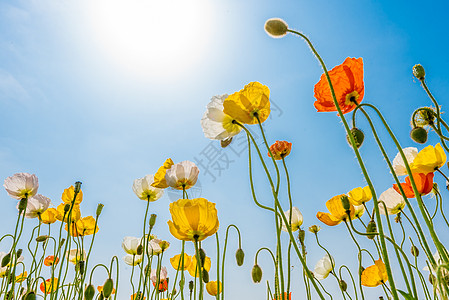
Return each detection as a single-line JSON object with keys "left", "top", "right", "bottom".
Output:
{"left": 410, "top": 143, "right": 446, "bottom": 174}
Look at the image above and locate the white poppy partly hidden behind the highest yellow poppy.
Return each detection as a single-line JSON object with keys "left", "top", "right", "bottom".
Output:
{"left": 201, "top": 94, "right": 242, "bottom": 140}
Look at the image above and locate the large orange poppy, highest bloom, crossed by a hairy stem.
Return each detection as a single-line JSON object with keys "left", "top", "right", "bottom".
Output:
{"left": 314, "top": 57, "right": 365, "bottom": 114}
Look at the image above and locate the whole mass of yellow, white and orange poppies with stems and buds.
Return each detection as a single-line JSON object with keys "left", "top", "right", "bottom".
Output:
{"left": 0, "top": 19, "right": 449, "bottom": 300}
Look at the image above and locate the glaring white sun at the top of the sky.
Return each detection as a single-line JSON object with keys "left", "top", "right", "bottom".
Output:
{"left": 88, "top": 0, "right": 212, "bottom": 79}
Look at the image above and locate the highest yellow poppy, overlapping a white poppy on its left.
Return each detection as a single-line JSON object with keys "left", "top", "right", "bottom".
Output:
{"left": 223, "top": 82, "right": 270, "bottom": 124}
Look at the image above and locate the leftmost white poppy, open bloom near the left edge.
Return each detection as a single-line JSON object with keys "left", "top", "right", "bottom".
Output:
{"left": 3, "top": 173, "right": 39, "bottom": 200}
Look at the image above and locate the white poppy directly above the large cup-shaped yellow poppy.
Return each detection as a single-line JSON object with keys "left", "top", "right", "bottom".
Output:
{"left": 165, "top": 160, "right": 200, "bottom": 190}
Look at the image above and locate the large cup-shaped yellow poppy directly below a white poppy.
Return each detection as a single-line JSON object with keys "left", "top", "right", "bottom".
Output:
{"left": 168, "top": 198, "right": 219, "bottom": 241}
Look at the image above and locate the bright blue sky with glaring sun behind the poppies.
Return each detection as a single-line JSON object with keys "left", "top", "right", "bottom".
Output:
{"left": 0, "top": 0, "right": 449, "bottom": 299}
